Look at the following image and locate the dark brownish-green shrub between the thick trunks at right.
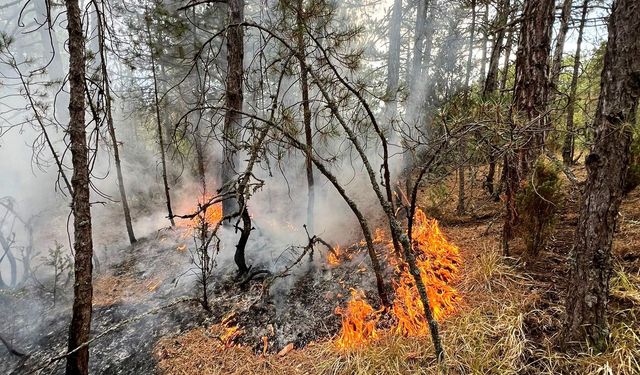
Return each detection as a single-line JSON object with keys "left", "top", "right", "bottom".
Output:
{"left": 517, "top": 158, "right": 564, "bottom": 255}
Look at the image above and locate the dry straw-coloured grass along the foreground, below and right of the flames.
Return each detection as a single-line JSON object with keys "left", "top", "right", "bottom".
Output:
{"left": 156, "top": 239, "right": 640, "bottom": 375}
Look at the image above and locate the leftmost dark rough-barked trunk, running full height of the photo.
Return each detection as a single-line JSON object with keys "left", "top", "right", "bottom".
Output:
{"left": 66, "top": 0, "right": 93, "bottom": 375}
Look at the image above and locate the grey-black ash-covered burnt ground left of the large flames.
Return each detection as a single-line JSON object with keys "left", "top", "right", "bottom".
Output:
{"left": 0, "top": 230, "right": 377, "bottom": 374}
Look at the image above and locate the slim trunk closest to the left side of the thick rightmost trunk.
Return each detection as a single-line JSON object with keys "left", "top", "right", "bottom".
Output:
{"left": 562, "top": 0, "right": 589, "bottom": 165}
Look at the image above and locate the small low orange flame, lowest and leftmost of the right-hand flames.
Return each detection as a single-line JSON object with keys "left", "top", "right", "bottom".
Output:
{"left": 335, "top": 289, "right": 382, "bottom": 348}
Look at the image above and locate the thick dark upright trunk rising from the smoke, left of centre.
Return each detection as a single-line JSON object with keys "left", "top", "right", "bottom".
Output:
{"left": 221, "top": 0, "right": 244, "bottom": 216}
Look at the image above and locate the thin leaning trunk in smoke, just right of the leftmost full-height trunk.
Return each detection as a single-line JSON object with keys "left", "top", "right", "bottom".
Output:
{"left": 94, "top": 1, "right": 136, "bottom": 244}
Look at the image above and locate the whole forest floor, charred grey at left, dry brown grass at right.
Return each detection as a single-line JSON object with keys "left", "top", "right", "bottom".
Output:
{"left": 0, "top": 162, "right": 640, "bottom": 375}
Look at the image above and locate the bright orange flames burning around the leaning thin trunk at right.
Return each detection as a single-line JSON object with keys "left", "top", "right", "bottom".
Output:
{"left": 336, "top": 210, "right": 461, "bottom": 348}
